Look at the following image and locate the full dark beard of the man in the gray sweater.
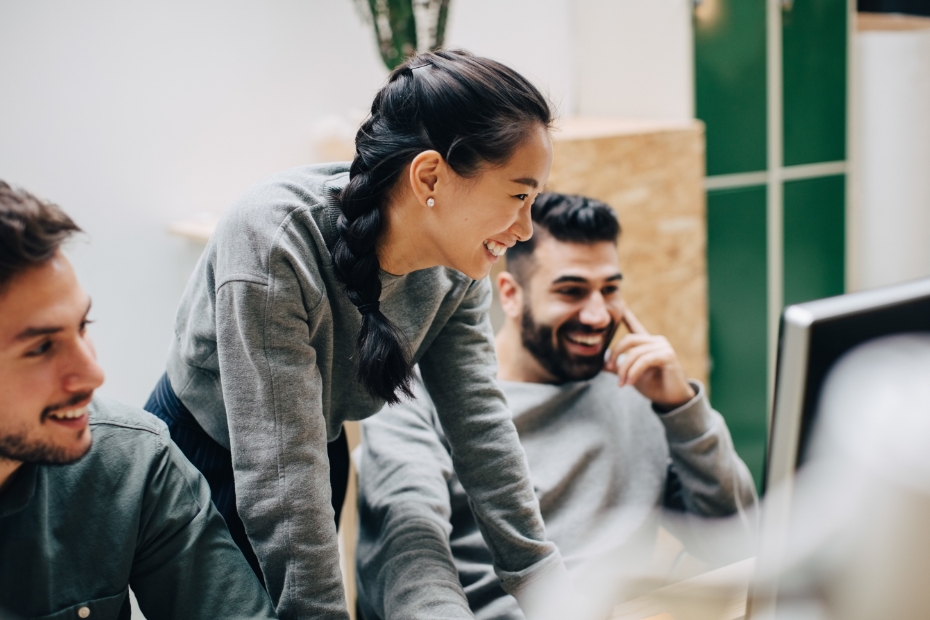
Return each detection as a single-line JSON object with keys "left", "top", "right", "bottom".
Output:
{"left": 520, "top": 307, "right": 617, "bottom": 383}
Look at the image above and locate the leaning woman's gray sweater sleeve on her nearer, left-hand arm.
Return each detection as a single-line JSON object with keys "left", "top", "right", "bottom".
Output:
{"left": 216, "top": 272, "right": 348, "bottom": 620}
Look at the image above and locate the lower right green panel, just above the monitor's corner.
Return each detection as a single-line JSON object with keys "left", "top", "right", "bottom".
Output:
{"left": 784, "top": 175, "right": 846, "bottom": 305}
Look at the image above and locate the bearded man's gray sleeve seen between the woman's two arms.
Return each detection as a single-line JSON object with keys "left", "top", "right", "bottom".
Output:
{"left": 356, "top": 381, "right": 474, "bottom": 620}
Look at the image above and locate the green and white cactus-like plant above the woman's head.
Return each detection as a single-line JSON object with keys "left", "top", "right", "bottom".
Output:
{"left": 356, "top": 0, "right": 451, "bottom": 71}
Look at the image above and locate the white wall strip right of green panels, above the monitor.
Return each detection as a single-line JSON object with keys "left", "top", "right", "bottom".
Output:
{"left": 851, "top": 25, "right": 930, "bottom": 289}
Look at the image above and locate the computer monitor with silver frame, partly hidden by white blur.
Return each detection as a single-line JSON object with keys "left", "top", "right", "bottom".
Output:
{"left": 766, "top": 278, "right": 930, "bottom": 489}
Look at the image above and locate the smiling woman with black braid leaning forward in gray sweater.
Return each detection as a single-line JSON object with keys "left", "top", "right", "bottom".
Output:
{"left": 146, "top": 51, "right": 571, "bottom": 620}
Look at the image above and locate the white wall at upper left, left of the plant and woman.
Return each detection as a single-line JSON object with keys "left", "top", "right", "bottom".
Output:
{"left": 0, "top": 0, "right": 385, "bottom": 405}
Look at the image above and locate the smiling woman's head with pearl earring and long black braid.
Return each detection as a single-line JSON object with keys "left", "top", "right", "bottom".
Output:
{"left": 333, "top": 52, "right": 552, "bottom": 403}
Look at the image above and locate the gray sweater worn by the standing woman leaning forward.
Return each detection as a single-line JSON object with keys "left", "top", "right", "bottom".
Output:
{"left": 168, "top": 164, "right": 564, "bottom": 619}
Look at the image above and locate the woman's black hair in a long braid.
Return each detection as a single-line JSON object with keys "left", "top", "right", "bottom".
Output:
{"left": 333, "top": 50, "right": 552, "bottom": 403}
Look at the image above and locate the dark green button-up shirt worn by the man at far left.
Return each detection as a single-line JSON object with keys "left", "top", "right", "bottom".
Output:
{"left": 0, "top": 397, "right": 275, "bottom": 620}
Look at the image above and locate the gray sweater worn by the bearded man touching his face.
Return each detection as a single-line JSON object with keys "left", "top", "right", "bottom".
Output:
{"left": 357, "top": 373, "right": 755, "bottom": 620}
